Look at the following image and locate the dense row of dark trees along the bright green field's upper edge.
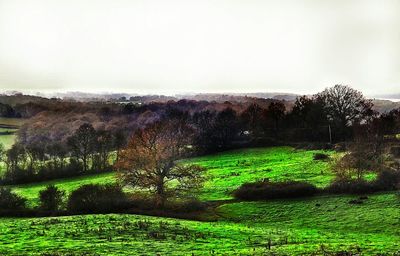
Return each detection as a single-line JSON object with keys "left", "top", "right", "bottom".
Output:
{"left": 192, "top": 85, "right": 378, "bottom": 152}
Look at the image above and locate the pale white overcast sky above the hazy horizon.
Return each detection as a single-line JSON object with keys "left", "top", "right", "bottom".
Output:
{"left": 0, "top": 0, "right": 400, "bottom": 94}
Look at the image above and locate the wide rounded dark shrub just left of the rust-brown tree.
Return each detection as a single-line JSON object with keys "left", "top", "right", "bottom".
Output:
{"left": 68, "top": 184, "right": 128, "bottom": 213}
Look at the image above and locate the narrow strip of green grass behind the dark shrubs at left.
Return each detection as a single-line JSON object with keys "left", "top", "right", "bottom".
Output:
{"left": 12, "top": 173, "right": 115, "bottom": 206}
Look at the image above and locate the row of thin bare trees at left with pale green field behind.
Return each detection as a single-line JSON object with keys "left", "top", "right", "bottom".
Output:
{"left": 0, "top": 124, "right": 126, "bottom": 184}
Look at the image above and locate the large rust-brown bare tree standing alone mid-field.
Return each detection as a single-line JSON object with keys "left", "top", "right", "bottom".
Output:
{"left": 116, "top": 121, "right": 203, "bottom": 207}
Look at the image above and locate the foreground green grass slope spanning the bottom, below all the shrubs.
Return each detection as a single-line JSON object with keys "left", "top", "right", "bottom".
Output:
{"left": 0, "top": 193, "right": 400, "bottom": 255}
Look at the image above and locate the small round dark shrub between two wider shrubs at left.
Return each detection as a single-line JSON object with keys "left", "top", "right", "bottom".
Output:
{"left": 39, "top": 185, "right": 65, "bottom": 211}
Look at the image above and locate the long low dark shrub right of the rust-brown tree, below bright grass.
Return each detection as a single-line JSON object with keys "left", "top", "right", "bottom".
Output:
{"left": 234, "top": 181, "right": 318, "bottom": 200}
